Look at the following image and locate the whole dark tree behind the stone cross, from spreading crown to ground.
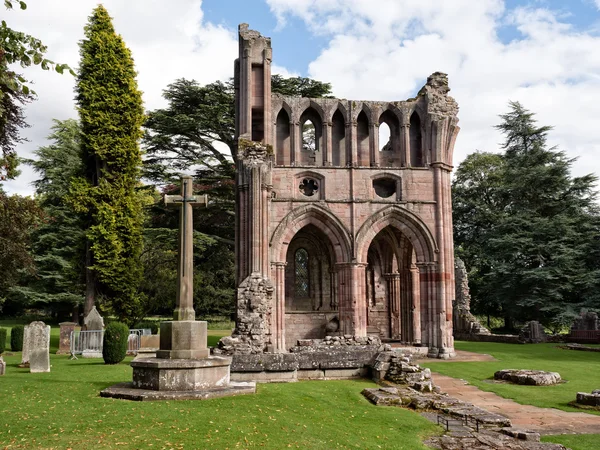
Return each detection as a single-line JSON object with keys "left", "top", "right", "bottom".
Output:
{"left": 143, "top": 75, "right": 331, "bottom": 315}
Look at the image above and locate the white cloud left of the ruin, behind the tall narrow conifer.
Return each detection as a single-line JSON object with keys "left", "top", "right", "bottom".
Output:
{"left": 2, "top": 0, "right": 238, "bottom": 194}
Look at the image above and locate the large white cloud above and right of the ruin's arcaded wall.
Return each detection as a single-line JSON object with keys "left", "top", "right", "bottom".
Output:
{"left": 267, "top": 0, "right": 600, "bottom": 183}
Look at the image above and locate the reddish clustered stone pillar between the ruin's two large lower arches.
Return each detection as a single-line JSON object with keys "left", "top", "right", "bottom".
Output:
{"left": 336, "top": 263, "right": 367, "bottom": 336}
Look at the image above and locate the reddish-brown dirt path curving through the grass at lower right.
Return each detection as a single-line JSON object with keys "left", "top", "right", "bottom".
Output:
{"left": 432, "top": 370, "right": 600, "bottom": 434}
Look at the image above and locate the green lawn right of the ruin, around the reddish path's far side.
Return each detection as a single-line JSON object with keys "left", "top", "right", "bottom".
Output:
{"left": 422, "top": 341, "right": 600, "bottom": 450}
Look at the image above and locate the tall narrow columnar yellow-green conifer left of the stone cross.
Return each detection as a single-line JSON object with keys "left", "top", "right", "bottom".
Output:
{"left": 71, "top": 5, "right": 144, "bottom": 322}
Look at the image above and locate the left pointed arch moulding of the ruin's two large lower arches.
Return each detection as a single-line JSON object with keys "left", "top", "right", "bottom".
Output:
{"left": 270, "top": 204, "right": 352, "bottom": 263}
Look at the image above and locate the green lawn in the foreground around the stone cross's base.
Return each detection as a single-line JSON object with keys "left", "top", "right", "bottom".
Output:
{"left": 0, "top": 328, "right": 440, "bottom": 450}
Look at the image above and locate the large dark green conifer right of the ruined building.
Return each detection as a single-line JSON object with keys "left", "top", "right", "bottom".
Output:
{"left": 453, "top": 102, "right": 600, "bottom": 327}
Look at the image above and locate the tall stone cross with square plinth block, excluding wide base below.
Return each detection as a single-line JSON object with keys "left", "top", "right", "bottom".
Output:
{"left": 156, "top": 175, "right": 209, "bottom": 359}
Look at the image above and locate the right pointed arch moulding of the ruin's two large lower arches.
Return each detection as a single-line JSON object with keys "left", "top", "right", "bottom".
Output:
{"left": 356, "top": 205, "right": 439, "bottom": 263}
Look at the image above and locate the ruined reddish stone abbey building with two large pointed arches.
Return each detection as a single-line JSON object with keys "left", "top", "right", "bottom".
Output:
{"left": 234, "top": 24, "right": 459, "bottom": 358}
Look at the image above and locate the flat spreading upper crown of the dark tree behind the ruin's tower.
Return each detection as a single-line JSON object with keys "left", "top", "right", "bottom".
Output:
{"left": 143, "top": 75, "right": 331, "bottom": 183}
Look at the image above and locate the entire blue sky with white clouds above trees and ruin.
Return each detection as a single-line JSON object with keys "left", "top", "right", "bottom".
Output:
{"left": 2, "top": 0, "right": 600, "bottom": 194}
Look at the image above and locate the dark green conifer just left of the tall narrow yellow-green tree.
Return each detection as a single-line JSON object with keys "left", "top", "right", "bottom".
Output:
{"left": 12, "top": 119, "right": 85, "bottom": 318}
